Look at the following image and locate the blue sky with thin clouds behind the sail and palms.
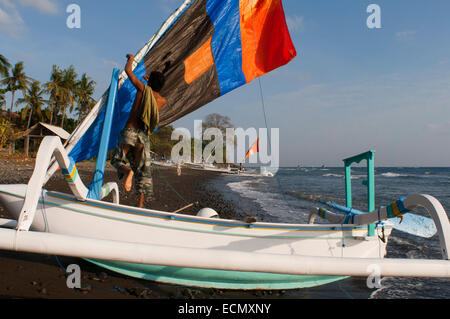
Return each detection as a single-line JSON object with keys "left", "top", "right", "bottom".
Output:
{"left": 0, "top": 0, "right": 450, "bottom": 167}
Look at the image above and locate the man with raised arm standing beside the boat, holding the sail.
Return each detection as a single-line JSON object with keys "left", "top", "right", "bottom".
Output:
{"left": 111, "top": 54, "right": 166, "bottom": 207}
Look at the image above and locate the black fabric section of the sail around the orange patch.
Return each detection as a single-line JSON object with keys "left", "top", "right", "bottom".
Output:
{"left": 144, "top": 0, "right": 220, "bottom": 127}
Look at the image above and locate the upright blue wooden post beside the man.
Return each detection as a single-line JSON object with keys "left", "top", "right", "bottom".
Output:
{"left": 89, "top": 69, "right": 119, "bottom": 200}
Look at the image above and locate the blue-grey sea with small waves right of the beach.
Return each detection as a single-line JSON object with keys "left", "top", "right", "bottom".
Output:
{"left": 212, "top": 167, "right": 450, "bottom": 299}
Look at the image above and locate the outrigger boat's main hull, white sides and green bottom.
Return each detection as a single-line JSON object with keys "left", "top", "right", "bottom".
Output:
{"left": 0, "top": 185, "right": 391, "bottom": 289}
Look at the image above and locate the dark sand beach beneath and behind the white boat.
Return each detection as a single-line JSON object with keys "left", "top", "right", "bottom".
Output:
{"left": 0, "top": 156, "right": 372, "bottom": 299}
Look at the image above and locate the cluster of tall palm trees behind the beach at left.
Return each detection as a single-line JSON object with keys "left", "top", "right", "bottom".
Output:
{"left": 0, "top": 54, "right": 96, "bottom": 131}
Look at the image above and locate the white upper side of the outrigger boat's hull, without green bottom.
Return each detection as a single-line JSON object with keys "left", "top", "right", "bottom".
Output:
{"left": 0, "top": 185, "right": 391, "bottom": 258}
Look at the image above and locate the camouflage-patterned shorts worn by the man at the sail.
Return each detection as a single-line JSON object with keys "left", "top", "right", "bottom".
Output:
{"left": 111, "top": 128, "right": 153, "bottom": 195}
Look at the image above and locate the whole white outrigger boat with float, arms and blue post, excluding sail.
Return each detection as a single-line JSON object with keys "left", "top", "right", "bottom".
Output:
{"left": 0, "top": 0, "right": 450, "bottom": 289}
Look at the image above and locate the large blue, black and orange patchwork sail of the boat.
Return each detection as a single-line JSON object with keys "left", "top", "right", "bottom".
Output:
{"left": 64, "top": 0, "right": 296, "bottom": 168}
